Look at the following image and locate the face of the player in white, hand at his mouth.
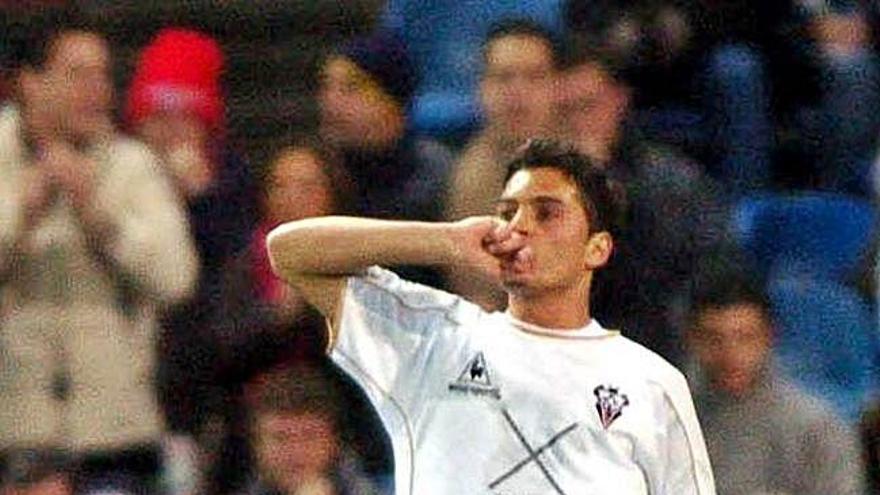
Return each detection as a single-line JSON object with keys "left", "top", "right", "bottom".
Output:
{"left": 497, "top": 167, "right": 610, "bottom": 294}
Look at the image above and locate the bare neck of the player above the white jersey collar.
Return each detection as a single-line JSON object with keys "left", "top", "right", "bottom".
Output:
{"left": 507, "top": 282, "right": 591, "bottom": 330}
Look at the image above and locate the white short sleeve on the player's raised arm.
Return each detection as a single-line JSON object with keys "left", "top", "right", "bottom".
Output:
{"left": 330, "top": 267, "right": 479, "bottom": 411}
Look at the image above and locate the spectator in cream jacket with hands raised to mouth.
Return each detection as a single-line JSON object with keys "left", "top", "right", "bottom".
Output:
{"left": 0, "top": 9, "right": 198, "bottom": 495}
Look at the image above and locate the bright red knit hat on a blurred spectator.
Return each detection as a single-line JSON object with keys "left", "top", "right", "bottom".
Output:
{"left": 126, "top": 28, "right": 224, "bottom": 129}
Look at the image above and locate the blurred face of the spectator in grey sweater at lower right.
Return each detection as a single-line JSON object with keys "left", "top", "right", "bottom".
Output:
{"left": 690, "top": 304, "right": 770, "bottom": 395}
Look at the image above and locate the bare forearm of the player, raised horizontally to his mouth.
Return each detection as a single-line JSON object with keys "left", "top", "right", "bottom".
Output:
{"left": 267, "top": 217, "right": 457, "bottom": 275}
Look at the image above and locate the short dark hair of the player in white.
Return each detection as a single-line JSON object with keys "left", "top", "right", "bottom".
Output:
{"left": 504, "top": 139, "right": 626, "bottom": 234}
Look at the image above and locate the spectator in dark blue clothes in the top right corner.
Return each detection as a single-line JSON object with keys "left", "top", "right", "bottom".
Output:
{"left": 780, "top": 0, "right": 880, "bottom": 195}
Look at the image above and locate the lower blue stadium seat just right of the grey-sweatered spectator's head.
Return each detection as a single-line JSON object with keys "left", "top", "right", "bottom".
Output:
{"left": 768, "top": 277, "right": 880, "bottom": 422}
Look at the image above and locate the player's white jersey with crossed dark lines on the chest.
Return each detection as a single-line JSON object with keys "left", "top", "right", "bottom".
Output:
{"left": 331, "top": 267, "right": 715, "bottom": 495}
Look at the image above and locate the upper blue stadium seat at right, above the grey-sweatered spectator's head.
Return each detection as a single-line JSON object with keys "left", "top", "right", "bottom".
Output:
{"left": 731, "top": 193, "right": 877, "bottom": 281}
